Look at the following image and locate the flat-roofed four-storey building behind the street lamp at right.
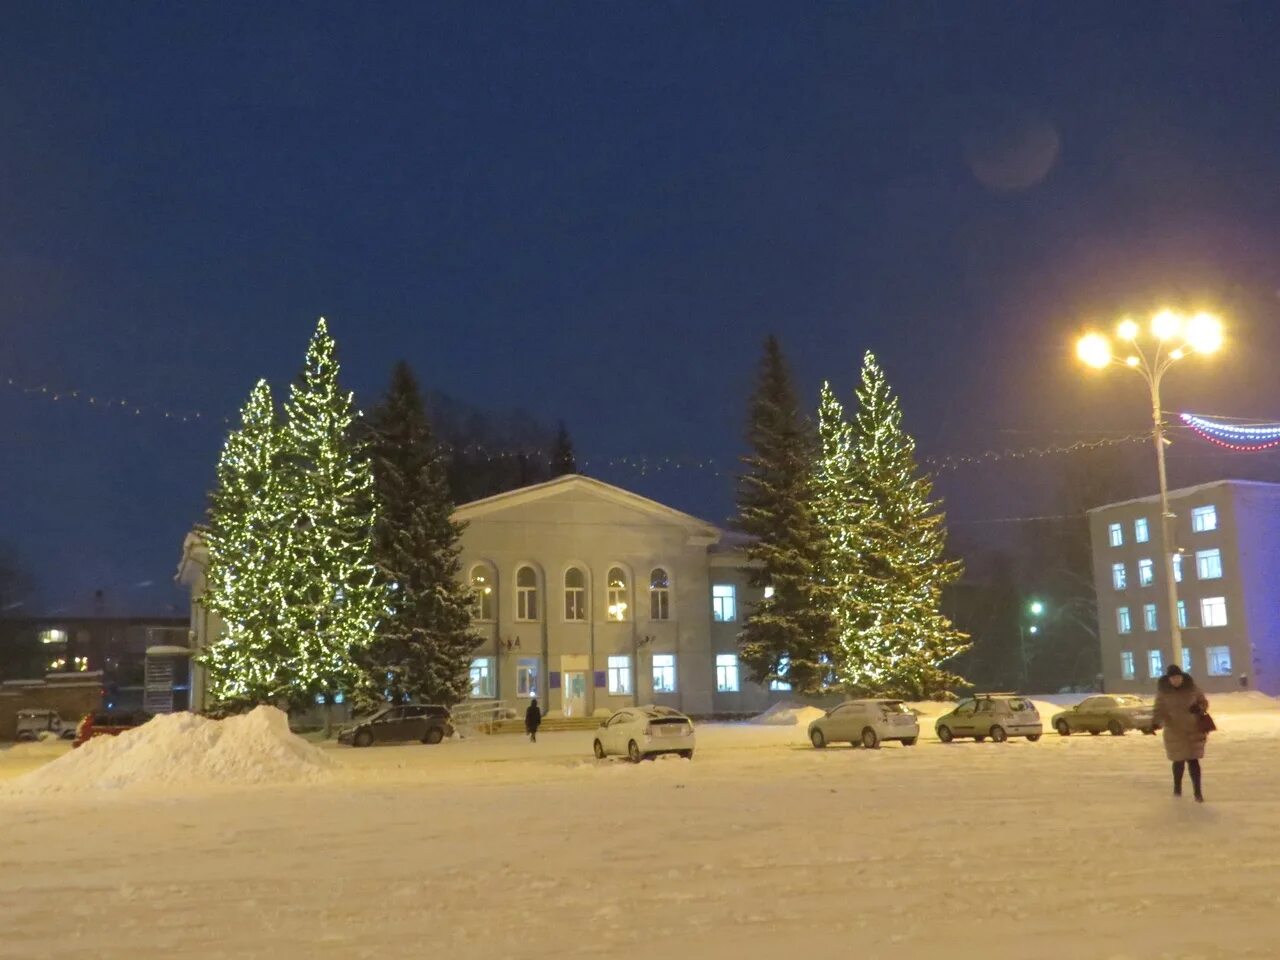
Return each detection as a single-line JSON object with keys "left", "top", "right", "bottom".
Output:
{"left": 1088, "top": 480, "right": 1280, "bottom": 695}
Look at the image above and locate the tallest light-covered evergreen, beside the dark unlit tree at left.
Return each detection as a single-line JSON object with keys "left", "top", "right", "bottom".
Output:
{"left": 279, "top": 317, "right": 387, "bottom": 703}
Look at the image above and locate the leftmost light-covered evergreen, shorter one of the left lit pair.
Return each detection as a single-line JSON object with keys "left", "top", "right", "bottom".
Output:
{"left": 204, "top": 380, "right": 292, "bottom": 707}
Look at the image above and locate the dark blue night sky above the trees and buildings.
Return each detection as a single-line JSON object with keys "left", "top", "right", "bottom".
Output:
{"left": 0, "top": 0, "right": 1280, "bottom": 612}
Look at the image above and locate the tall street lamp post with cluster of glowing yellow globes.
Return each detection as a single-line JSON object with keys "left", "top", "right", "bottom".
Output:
{"left": 1076, "top": 310, "right": 1222, "bottom": 664}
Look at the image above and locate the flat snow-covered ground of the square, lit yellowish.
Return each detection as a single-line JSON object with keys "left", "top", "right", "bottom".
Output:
{"left": 0, "top": 698, "right": 1280, "bottom": 960}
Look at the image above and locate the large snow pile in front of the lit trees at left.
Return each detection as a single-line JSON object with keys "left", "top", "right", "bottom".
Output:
{"left": 8, "top": 707, "right": 333, "bottom": 794}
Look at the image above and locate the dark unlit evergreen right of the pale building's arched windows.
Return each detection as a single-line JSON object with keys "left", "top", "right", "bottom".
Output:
{"left": 737, "top": 337, "right": 832, "bottom": 692}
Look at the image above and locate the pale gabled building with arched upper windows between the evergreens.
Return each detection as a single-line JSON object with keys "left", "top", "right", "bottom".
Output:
{"left": 179, "top": 475, "right": 790, "bottom": 717}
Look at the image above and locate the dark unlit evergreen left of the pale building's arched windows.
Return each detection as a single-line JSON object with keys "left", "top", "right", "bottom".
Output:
{"left": 360, "top": 362, "right": 477, "bottom": 705}
